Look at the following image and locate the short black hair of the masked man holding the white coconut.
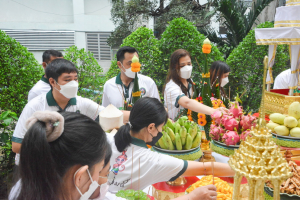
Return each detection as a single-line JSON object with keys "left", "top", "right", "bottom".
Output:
{"left": 45, "top": 58, "right": 78, "bottom": 81}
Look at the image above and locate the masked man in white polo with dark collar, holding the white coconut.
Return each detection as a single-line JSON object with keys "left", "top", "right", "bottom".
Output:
{"left": 12, "top": 58, "right": 128, "bottom": 164}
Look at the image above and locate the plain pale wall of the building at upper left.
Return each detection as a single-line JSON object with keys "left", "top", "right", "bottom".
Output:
{"left": 0, "top": 0, "right": 115, "bottom": 72}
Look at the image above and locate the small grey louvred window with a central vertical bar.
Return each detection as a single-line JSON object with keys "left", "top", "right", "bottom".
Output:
{"left": 86, "top": 32, "right": 112, "bottom": 60}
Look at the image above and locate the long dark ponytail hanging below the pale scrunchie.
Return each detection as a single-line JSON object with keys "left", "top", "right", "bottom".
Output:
{"left": 17, "top": 121, "right": 62, "bottom": 200}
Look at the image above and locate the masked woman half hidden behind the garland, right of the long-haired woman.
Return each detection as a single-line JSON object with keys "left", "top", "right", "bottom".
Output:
{"left": 209, "top": 61, "right": 230, "bottom": 98}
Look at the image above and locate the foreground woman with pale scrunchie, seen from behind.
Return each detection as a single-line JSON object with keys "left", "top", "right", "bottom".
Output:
{"left": 9, "top": 111, "right": 109, "bottom": 200}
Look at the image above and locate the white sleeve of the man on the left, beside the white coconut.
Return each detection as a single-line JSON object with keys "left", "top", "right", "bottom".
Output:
{"left": 80, "top": 97, "right": 105, "bottom": 120}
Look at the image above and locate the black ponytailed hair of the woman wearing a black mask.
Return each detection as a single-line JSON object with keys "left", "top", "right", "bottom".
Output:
{"left": 115, "top": 97, "right": 168, "bottom": 152}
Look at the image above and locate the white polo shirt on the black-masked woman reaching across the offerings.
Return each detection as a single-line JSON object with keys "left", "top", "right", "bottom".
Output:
{"left": 108, "top": 137, "right": 188, "bottom": 193}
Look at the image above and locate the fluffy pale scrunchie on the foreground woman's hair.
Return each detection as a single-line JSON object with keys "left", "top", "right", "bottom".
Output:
{"left": 26, "top": 111, "right": 65, "bottom": 142}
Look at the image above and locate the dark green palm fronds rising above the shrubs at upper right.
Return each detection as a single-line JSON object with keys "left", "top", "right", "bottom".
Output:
{"left": 199, "top": 0, "right": 273, "bottom": 57}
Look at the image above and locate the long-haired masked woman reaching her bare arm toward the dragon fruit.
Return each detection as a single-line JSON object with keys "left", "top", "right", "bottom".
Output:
{"left": 164, "top": 49, "right": 223, "bottom": 119}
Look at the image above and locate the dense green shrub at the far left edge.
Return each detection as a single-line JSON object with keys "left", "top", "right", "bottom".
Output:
{"left": 0, "top": 30, "right": 43, "bottom": 115}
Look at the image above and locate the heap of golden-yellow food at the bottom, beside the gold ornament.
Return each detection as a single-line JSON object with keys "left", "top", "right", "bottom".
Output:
{"left": 186, "top": 175, "right": 233, "bottom": 200}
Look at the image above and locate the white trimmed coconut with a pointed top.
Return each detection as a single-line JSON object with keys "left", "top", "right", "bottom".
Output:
{"left": 99, "top": 104, "right": 123, "bottom": 132}
